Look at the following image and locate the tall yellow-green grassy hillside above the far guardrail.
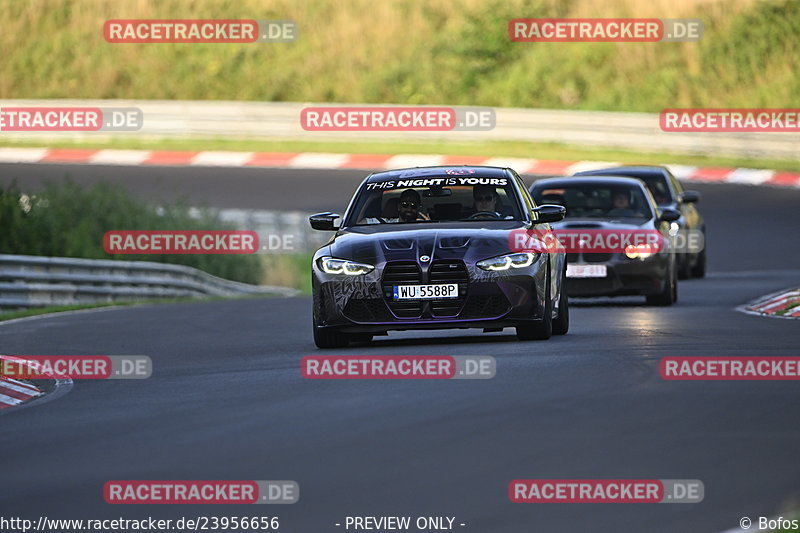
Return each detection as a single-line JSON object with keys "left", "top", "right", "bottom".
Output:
{"left": 0, "top": 0, "right": 800, "bottom": 112}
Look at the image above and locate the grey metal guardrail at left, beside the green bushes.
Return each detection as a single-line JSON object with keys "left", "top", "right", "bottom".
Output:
{"left": 0, "top": 255, "right": 298, "bottom": 311}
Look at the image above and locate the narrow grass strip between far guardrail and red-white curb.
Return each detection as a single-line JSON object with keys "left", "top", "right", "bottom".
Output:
{"left": 0, "top": 138, "right": 800, "bottom": 172}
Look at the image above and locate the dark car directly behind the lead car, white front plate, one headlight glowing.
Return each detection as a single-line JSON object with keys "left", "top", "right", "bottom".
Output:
{"left": 530, "top": 176, "right": 680, "bottom": 305}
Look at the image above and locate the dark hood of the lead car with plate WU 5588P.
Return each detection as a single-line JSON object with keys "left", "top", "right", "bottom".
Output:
{"left": 327, "top": 221, "right": 527, "bottom": 265}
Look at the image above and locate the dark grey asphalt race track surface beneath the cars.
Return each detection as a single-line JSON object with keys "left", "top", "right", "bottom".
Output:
{"left": 0, "top": 165, "right": 800, "bottom": 533}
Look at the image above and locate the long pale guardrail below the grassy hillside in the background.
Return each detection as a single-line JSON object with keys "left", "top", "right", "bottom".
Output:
{"left": 0, "top": 100, "right": 800, "bottom": 159}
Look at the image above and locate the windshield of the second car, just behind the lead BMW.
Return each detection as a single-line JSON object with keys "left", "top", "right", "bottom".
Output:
{"left": 533, "top": 185, "right": 653, "bottom": 219}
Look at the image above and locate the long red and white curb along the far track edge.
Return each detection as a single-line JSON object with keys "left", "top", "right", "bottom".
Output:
{"left": 0, "top": 148, "right": 800, "bottom": 188}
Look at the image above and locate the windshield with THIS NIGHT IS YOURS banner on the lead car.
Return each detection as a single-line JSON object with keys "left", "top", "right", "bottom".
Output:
{"left": 346, "top": 175, "right": 522, "bottom": 226}
